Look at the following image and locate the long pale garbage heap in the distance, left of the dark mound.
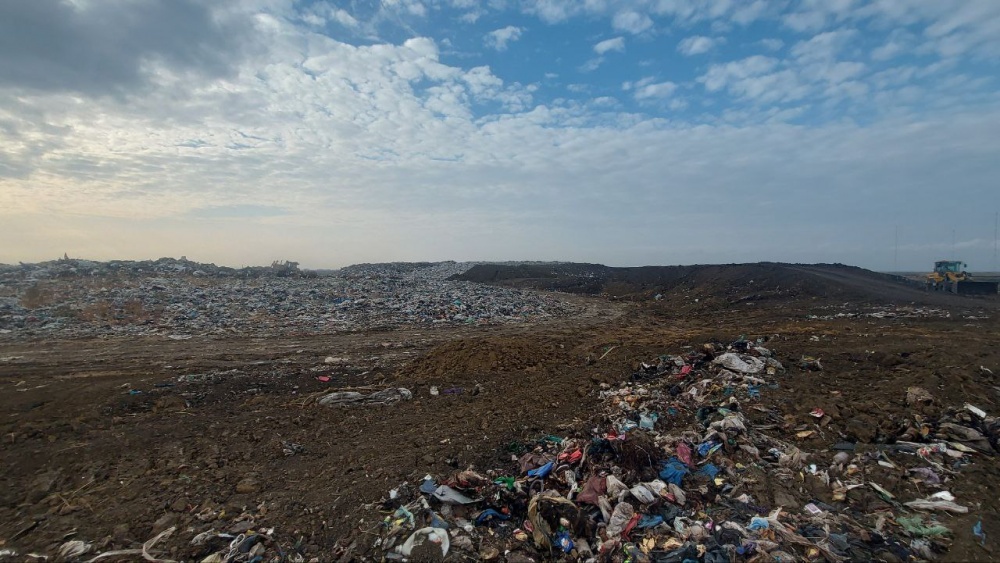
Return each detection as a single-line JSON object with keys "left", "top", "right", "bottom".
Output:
{"left": 0, "top": 259, "right": 574, "bottom": 339}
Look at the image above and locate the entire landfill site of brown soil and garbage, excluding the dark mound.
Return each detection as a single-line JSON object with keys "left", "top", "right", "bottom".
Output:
{"left": 0, "top": 259, "right": 1000, "bottom": 563}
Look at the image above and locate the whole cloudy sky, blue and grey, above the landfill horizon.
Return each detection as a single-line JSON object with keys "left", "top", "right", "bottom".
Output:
{"left": 0, "top": 0, "right": 1000, "bottom": 270}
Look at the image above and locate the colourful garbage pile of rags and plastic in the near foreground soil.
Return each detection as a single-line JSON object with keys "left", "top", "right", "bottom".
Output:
{"left": 360, "top": 338, "right": 1000, "bottom": 563}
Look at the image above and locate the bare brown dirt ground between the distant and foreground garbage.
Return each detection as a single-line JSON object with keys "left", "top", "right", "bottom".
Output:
{"left": 0, "top": 288, "right": 1000, "bottom": 561}
